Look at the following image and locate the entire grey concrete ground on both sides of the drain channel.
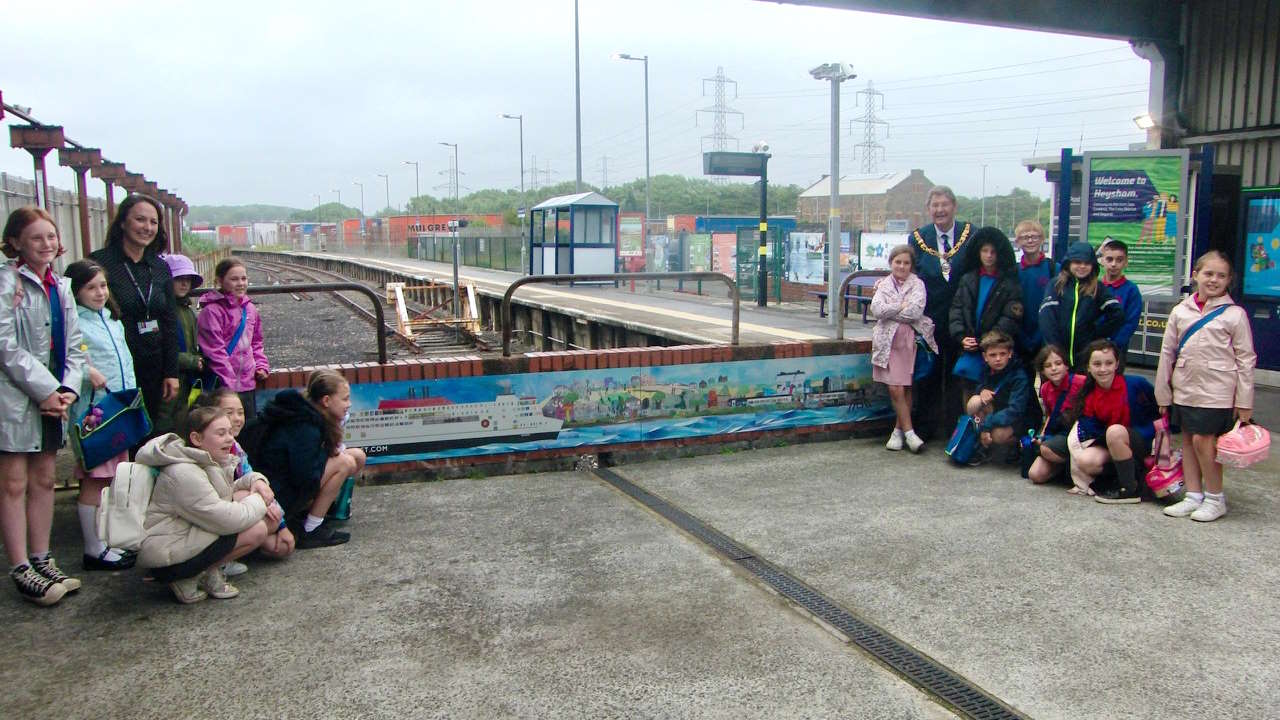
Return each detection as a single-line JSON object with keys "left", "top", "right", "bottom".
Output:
{"left": 0, "top": 391, "right": 1280, "bottom": 719}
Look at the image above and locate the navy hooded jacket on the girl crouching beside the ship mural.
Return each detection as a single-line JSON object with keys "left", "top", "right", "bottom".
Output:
{"left": 239, "top": 389, "right": 333, "bottom": 518}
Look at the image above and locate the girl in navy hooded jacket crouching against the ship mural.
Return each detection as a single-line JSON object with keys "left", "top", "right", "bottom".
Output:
{"left": 241, "top": 370, "right": 365, "bottom": 550}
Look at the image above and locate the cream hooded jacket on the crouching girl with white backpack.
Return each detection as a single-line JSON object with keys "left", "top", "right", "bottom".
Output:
{"left": 137, "top": 433, "right": 266, "bottom": 568}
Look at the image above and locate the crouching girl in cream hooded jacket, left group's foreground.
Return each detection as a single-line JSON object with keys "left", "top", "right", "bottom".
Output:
{"left": 137, "top": 407, "right": 280, "bottom": 603}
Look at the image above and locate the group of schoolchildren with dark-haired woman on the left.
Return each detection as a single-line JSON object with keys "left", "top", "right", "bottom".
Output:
{"left": 0, "top": 206, "right": 365, "bottom": 606}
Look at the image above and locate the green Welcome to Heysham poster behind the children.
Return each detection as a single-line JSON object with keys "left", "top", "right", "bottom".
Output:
{"left": 1082, "top": 150, "right": 1188, "bottom": 297}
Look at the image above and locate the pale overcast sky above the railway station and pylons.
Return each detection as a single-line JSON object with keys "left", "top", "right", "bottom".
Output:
{"left": 0, "top": 0, "right": 1148, "bottom": 211}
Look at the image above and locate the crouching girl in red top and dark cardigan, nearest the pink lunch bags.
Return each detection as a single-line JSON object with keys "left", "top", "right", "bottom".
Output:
{"left": 1068, "top": 340, "right": 1147, "bottom": 503}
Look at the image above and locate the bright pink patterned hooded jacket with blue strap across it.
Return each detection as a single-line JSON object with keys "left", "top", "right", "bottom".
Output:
{"left": 196, "top": 290, "right": 270, "bottom": 392}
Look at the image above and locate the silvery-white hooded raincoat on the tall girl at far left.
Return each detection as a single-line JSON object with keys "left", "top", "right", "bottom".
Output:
{"left": 0, "top": 263, "right": 84, "bottom": 452}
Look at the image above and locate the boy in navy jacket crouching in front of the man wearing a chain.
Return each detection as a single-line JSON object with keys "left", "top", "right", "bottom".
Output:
{"left": 965, "top": 331, "right": 1029, "bottom": 465}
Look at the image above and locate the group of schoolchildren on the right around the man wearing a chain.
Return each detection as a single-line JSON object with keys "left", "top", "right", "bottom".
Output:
{"left": 870, "top": 215, "right": 1256, "bottom": 521}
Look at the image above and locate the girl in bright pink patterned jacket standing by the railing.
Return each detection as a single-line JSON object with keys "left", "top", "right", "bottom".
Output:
{"left": 196, "top": 258, "right": 270, "bottom": 420}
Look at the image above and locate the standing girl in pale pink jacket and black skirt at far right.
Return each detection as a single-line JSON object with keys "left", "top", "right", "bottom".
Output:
{"left": 1156, "top": 250, "right": 1257, "bottom": 523}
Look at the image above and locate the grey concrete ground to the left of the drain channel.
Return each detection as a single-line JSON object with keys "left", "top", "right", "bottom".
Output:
{"left": 0, "top": 474, "right": 950, "bottom": 720}
